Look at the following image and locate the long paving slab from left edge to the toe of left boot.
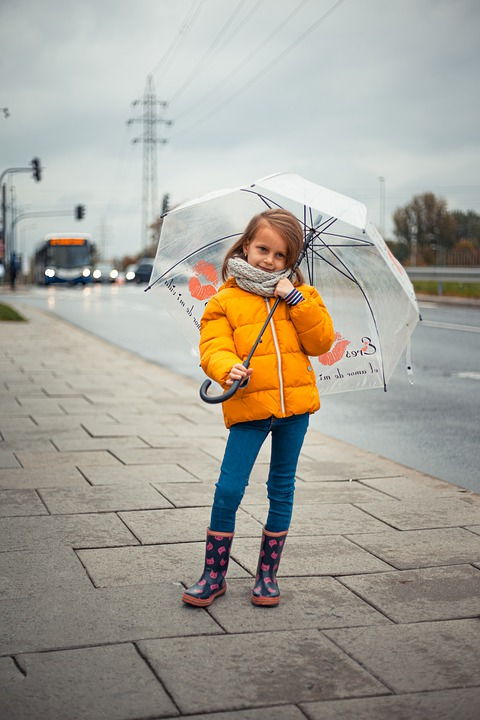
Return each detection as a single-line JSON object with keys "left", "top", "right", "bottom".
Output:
{"left": 0, "top": 583, "right": 223, "bottom": 655}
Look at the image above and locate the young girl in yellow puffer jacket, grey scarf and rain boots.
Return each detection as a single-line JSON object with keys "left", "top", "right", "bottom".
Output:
{"left": 182, "top": 209, "right": 334, "bottom": 607}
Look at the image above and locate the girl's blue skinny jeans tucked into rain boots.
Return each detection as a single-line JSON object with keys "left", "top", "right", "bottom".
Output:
{"left": 210, "top": 413, "right": 310, "bottom": 532}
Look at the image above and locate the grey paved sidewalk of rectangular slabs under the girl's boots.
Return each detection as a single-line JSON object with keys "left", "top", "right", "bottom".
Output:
{"left": 0, "top": 303, "right": 480, "bottom": 720}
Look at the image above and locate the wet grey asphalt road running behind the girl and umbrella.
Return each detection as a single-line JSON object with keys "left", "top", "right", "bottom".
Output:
{"left": 4, "top": 285, "right": 480, "bottom": 492}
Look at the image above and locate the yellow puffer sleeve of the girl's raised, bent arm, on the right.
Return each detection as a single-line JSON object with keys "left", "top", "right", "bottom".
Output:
{"left": 290, "top": 286, "right": 335, "bottom": 357}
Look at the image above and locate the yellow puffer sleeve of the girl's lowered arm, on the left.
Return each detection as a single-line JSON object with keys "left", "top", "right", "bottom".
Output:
{"left": 200, "top": 297, "right": 242, "bottom": 386}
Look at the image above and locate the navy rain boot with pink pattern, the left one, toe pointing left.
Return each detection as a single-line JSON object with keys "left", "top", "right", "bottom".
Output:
{"left": 182, "top": 529, "right": 233, "bottom": 607}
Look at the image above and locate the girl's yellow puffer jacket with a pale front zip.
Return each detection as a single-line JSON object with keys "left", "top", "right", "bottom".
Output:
{"left": 200, "top": 278, "right": 334, "bottom": 427}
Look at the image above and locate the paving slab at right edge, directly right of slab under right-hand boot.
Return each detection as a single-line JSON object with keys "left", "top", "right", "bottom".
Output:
{"left": 341, "top": 565, "right": 480, "bottom": 623}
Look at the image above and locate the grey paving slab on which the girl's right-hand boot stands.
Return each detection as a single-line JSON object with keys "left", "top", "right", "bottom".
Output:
{"left": 209, "top": 573, "right": 390, "bottom": 633}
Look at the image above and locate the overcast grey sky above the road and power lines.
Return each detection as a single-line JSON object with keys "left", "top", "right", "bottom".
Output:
{"left": 0, "top": 0, "right": 480, "bottom": 257}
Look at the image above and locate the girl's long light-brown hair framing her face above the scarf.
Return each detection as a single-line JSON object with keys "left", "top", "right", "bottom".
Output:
{"left": 222, "top": 209, "right": 305, "bottom": 285}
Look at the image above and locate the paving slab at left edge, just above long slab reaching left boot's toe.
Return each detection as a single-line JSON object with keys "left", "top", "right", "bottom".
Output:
{"left": 0, "top": 547, "right": 92, "bottom": 599}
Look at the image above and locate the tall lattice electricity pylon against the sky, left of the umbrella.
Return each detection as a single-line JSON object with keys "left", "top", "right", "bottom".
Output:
{"left": 127, "top": 75, "right": 172, "bottom": 250}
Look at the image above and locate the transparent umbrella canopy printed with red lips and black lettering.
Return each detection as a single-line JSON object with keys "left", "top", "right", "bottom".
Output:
{"left": 147, "top": 174, "right": 419, "bottom": 394}
